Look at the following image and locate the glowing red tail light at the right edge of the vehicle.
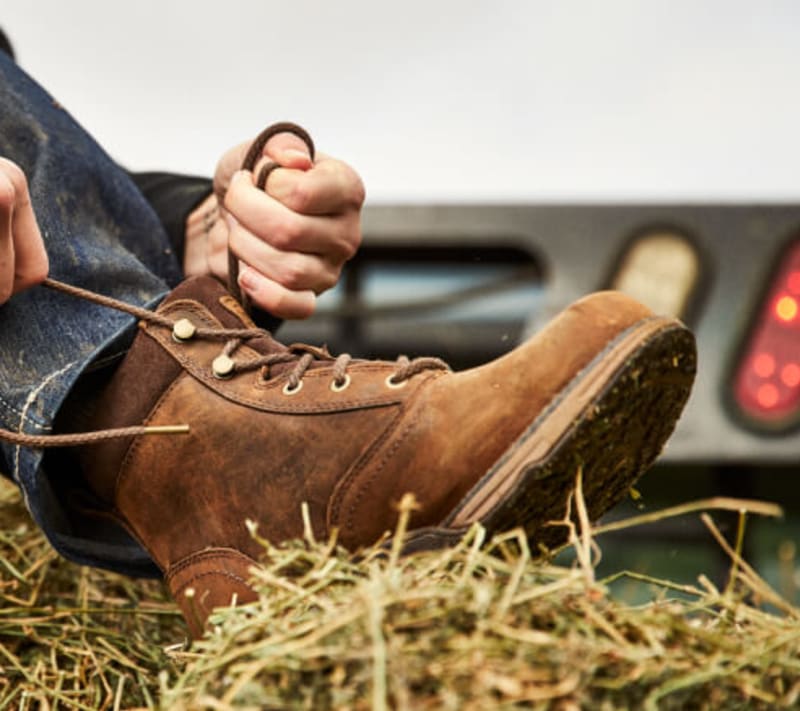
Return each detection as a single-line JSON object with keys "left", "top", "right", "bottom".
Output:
{"left": 734, "top": 242, "right": 800, "bottom": 429}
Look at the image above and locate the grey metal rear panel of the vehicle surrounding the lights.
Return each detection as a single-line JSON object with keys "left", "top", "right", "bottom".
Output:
{"left": 280, "top": 204, "right": 800, "bottom": 465}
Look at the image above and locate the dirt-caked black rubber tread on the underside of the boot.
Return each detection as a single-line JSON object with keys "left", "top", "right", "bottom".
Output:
{"left": 406, "top": 322, "right": 696, "bottom": 551}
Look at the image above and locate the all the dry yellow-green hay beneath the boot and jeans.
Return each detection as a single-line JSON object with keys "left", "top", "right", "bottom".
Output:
{"left": 0, "top": 480, "right": 800, "bottom": 711}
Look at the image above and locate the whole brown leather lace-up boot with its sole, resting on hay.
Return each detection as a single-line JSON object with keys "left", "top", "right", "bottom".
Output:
{"left": 67, "top": 278, "right": 695, "bottom": 635}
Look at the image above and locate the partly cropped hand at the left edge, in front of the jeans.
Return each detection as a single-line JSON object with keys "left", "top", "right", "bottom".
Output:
{"left": 0, "top": 158, "right": 49, "bottom": 304}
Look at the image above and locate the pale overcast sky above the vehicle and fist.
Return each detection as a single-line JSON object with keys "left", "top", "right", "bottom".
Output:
{"left": 0, "top": 0, "right": 800, "bottom": 202}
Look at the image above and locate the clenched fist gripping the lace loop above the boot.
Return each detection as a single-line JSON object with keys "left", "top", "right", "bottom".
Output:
{"left": 184, "top": 133, "right": 364, "bottom": 318}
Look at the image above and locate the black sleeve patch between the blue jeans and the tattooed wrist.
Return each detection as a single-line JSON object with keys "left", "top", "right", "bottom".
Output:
{"left": 129, "top": 173, "right": 212, "bottom": 262}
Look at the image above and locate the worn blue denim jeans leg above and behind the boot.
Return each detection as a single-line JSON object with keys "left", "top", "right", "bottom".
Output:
{"left": 0, "top": 52, "right": 182, "bottom": 575}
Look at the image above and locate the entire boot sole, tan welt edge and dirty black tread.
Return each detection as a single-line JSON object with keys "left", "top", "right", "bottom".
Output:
{"left": 404, "top": 317, "right": 696, "bottom": 552}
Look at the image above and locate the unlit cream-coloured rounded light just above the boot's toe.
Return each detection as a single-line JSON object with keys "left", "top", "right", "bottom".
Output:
{"left": 611, "top": 230, "right": 700, "bottom": 318}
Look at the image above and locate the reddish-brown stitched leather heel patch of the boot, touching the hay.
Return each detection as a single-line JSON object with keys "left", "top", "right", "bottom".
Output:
{"left": 165, "top": 548, "right": 258, "bottom": 639}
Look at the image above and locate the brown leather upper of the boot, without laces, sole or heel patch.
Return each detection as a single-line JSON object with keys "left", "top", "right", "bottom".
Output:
{"left": 79, "top": 280, "right": 650, "bottom": 570}
